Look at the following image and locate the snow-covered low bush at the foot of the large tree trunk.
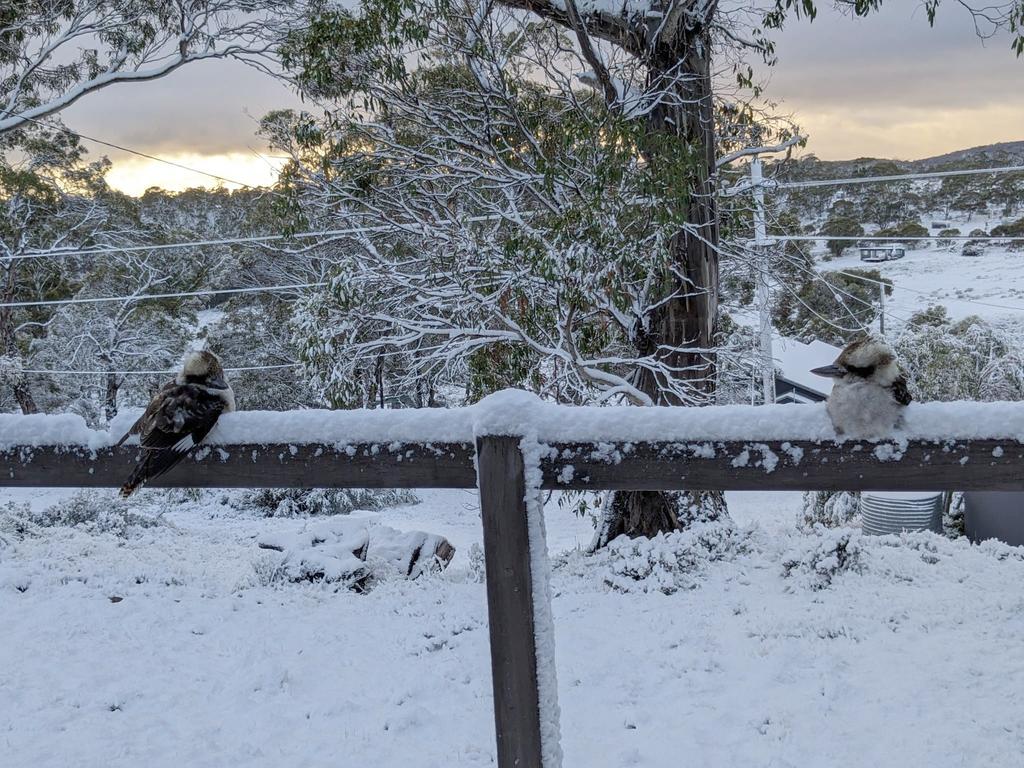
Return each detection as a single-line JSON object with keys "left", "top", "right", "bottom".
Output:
{"left": 596, "top": 521, "right": 746, "bottom": 595}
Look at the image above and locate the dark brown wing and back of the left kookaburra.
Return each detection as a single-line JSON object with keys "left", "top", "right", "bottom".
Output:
{"left": 121, "top": 384, "right": 224, "bottom": 496}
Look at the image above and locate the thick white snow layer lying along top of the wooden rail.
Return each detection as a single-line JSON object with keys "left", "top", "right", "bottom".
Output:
{"left": 6, "top": 390, "right": 1024, "bottom": 451}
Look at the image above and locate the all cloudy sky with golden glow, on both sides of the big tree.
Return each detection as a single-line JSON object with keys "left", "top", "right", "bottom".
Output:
{"left": 63, "top": 0, "right": 1024, "bottom": 195}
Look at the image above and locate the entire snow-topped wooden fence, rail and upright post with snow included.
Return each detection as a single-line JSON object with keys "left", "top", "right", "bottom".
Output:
{"left": 6, "top": 391, "right": 1024, "bottom": 768}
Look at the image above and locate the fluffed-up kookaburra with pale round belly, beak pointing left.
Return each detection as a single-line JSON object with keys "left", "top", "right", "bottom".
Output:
{"left": 811, "top": 336, "right": 910, "bottom": 438}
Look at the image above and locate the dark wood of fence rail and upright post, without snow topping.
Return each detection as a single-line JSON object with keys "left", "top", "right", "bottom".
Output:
{"left": 0, "top": 435, "right": 1024, "bottom": 768}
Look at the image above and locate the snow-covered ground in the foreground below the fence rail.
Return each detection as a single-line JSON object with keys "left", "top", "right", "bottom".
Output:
{"left": 0, "top": 490, "right": 1024, "bottom": 768}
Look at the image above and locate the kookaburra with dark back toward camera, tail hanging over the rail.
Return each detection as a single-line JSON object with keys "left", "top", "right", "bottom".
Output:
{"left": 118, "top": 351, "right": 234, "bottom": 497}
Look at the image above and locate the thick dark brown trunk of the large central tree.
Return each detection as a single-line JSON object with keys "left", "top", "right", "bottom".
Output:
{"left": 595, "top": 15, "right": 728, "bottom": 547}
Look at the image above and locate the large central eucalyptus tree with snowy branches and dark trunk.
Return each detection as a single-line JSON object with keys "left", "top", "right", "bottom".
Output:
{"left": 271, "top": 0, "right": 1016, "bottom": 536}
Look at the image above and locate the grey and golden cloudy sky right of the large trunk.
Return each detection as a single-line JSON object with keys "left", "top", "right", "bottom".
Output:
{"left": 768, "top": 3, "right": 1024, "bottom": 159}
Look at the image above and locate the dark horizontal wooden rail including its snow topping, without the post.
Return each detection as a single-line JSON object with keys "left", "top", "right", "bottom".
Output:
{"left": 6, "top": 392, "right": 1024, "bottom": 490}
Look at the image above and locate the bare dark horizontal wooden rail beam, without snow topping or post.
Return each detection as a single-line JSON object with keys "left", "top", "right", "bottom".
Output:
{"left": 0, "top": 438, "right": 1024, "bottom": 490}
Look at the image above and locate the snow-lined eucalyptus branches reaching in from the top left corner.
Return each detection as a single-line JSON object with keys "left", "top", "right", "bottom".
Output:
{"left": 0, "top": 0, "right": 301, "bottom": 134}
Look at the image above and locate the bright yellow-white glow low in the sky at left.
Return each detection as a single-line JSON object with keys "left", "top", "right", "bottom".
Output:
{"left": 106, "top": 151, "right": 282, "bottom": 197}
